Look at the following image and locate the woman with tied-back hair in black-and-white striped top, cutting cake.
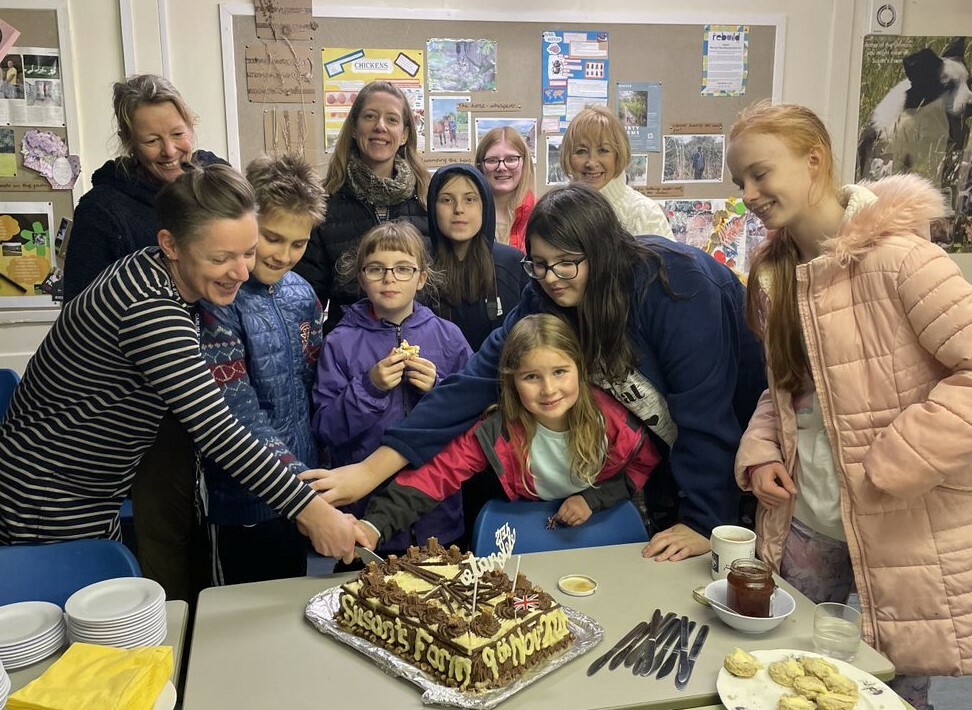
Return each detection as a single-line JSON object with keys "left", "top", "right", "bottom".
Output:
{"left": 0, "top": 165, "right": 355, "bottom": 560}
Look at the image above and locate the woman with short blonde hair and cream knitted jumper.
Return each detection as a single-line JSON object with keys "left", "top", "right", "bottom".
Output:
{"left": 560, "top": 106, "right": 675, "bottom": 241}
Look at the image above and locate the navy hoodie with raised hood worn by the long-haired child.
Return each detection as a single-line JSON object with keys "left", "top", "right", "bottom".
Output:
{"left": 428, "top": 164, "right": 530, "bottom": 350}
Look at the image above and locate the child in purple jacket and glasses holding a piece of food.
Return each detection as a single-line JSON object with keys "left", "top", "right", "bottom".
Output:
{"left": 313, "top": 222, "right": 472, "bottom": 568}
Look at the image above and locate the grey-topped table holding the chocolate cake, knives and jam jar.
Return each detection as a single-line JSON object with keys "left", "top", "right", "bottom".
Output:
{"left": 183, "top": 544, "right": 894, "bottom": 710}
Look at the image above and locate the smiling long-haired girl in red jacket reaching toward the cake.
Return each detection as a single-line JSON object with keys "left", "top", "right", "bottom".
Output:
{"left": 360, "top": 315, "right": 660, "bottom": 545}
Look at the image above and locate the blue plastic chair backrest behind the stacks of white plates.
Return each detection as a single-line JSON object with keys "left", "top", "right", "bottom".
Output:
{"left": 0, "top": 540, "right": 142, "bottom": 608}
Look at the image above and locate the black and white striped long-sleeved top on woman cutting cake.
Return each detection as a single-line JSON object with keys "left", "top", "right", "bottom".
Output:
{"left": 0, "top": 247, "right": 314, "bottom": 544}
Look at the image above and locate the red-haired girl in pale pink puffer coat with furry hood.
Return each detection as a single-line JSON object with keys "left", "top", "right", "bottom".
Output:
{"left": 727, "top": 102, "right": 972, "bottom": 708}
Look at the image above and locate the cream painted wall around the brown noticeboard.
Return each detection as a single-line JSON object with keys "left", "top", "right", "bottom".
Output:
{"left": 0, "top": 0, "right": 972, "bottom": 371}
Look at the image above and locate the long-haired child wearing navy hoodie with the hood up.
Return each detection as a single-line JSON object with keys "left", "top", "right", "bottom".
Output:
{"left": 429, "top": 165, "right": 529, "bottom": 350}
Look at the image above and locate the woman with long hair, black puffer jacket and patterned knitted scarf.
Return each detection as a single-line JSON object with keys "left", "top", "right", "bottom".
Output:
{"left": 294, "top": 81, "right": 429, "bottom": 335}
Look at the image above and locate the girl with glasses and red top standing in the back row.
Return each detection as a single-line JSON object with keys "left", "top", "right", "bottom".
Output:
{"left": 476, "top": 126, "right": 537, "bottom": 251}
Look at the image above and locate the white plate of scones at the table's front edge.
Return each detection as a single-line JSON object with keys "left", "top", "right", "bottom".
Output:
{"left": 716, "top": 648, "right": 904, "bottom": 710}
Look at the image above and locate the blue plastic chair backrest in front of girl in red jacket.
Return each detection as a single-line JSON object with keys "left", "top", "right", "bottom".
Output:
{"left": 471, "top": 499, "right": 648, "bottom": 557}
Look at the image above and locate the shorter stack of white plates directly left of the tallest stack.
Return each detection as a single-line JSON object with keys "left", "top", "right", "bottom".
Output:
{"left": 0, "top": 602, "right": 64, "bottom": 676}
